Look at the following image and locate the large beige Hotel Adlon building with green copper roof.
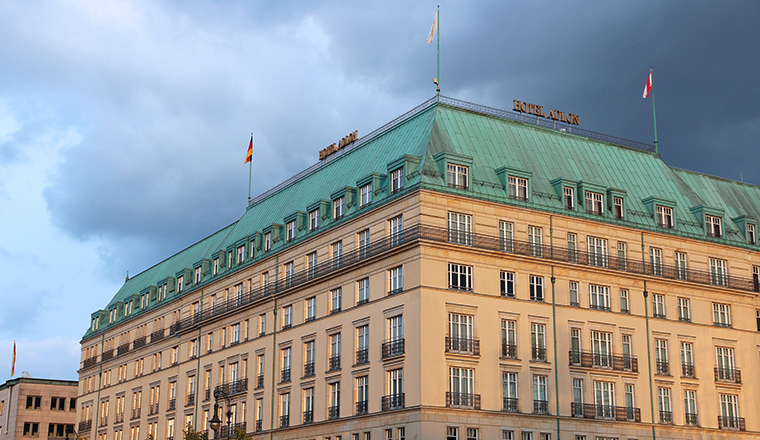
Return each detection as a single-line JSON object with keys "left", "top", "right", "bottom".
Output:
{"left": 77, "top": 97, "right": 760, "bottom": 440}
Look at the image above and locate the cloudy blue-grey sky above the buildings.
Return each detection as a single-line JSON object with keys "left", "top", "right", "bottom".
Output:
{"left": 0, "top": 0, "right": 760, "bottom": 382}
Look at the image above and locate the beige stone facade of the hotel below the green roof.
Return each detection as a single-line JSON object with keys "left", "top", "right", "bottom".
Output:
{"left": 77, "top": 189, "right": 760, "bottom": 440}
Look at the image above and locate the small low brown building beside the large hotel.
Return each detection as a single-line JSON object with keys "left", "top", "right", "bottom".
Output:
{"left": 0, "top": 377, "right": 79, "bottom": 440}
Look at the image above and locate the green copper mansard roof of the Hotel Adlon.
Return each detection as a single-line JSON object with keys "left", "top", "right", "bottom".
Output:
{"left": 84, "top": 97, "right": 760, "bottom": 338}
